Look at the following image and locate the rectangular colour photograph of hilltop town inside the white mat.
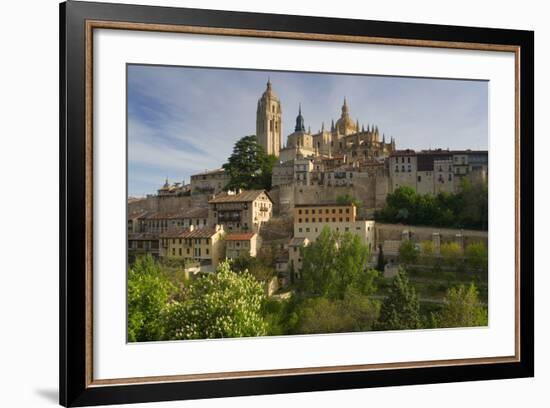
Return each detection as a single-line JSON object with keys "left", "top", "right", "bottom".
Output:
{"left": 126, "top": 63, "right": 492, "bottom": 343}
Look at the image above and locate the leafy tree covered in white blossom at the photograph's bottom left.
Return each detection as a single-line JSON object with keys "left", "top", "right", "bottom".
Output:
{"left": 164, "top": 261, "right": 267, "bottom": 340}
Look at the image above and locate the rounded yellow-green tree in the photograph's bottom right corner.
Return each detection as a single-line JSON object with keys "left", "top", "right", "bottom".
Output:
{"left": 434, "top": 283, "right": 488, "bottom": 327}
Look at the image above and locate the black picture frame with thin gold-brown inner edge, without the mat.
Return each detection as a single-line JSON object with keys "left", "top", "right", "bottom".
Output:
{"left": 59, "top": 1, "right": 534, "bottom": 406}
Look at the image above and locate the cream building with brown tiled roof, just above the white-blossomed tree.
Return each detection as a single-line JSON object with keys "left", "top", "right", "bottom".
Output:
{"left": 160, "top": 225, "right": 225, "bottom": 270}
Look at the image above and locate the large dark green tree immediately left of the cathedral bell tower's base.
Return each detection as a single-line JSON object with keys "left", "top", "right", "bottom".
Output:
{"left": 223, "top": 135, "right": 277, "bottom": 190}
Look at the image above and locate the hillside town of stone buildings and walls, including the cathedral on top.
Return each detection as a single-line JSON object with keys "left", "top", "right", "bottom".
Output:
{"left": 127, "top": 81, "right": 488, "bottom": 296}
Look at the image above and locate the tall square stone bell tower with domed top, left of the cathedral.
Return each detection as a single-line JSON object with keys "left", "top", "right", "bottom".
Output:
{"left": 256, "top": 80, "right": 282, "bottom": 157}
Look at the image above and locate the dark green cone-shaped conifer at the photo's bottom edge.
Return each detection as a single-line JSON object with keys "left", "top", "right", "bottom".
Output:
{"left": 375, "top": 269, "right": 422, "bottom": 330}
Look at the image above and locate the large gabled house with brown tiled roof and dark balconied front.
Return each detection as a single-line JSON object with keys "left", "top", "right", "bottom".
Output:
{"left": 208, "top": 190, "right": 273, "bottom": 232}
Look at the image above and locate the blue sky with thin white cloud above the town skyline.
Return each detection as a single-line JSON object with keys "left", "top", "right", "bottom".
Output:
{"left": 128, "top": 65, "right": 488, "bottom": 196}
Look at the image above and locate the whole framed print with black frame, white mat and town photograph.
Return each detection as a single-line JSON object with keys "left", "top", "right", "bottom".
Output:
{"left": 60, "top": 1, "right": 534, "bottom": 406}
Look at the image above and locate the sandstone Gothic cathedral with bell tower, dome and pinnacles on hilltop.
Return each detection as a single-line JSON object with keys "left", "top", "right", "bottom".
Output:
{"left": 256, "top": 80, "right": 395, "bottom": 166}
